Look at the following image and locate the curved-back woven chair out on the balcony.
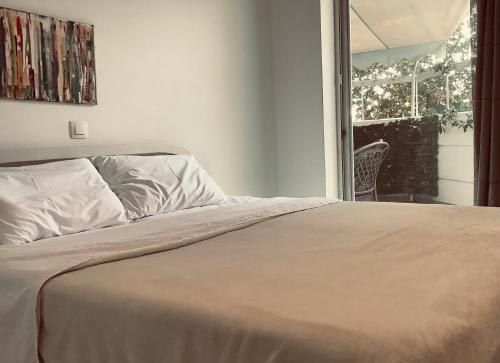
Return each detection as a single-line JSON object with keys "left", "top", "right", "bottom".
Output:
{"left": 354, "top": 140, "right": 389, "bottom": 202}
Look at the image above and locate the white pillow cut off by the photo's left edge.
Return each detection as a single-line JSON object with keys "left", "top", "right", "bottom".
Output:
{"left": 0, "top": 159, "right": 127, "bottom": 244}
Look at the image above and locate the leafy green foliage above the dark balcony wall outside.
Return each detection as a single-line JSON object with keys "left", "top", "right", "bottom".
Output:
{"left": 352, "top": 18, "right": 475, "bottom": 131}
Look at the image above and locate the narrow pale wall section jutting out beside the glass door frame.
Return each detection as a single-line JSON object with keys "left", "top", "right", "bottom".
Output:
{"left": 271, "top": 0, "right": 336, "bottom": 197}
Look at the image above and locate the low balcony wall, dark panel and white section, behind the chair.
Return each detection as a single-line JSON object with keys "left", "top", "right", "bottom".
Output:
{"left": 353, "top": 113, "right": 474, "bottom": 205}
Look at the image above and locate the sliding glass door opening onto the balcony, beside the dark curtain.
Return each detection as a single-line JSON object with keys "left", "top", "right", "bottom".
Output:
{"left": 337, "top": 0, "right": 474, "bottom": 205}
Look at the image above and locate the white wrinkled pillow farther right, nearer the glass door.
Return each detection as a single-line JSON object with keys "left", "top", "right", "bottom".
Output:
{"left": 92, "top": 155, "right": 225, "bottom": 219}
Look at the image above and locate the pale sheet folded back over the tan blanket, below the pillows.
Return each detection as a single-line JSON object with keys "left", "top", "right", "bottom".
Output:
{"left": 0, "top": 198, "right": 332, "bottom": 363}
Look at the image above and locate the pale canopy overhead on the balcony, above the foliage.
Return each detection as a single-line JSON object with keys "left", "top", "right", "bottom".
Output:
{"left": 351, "top": 0, "right": 470, "bottom": 68}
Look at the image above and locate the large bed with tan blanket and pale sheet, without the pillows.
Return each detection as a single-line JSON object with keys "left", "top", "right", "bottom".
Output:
{"left": 0, "top": 148, "right": 500, "bottom": 363}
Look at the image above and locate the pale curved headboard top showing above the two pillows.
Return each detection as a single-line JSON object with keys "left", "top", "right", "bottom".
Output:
{"left": 0, "top": 143, "right": 198, "bottom": 168}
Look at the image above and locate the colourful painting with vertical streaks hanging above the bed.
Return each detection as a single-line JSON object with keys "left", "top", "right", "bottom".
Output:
{"left": 0, "top": 7, "right": 97, "bottom": 104}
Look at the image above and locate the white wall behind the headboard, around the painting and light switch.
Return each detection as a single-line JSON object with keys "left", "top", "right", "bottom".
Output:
{"left": 0, "top": 0, "right": 278, "bottom": 196}
